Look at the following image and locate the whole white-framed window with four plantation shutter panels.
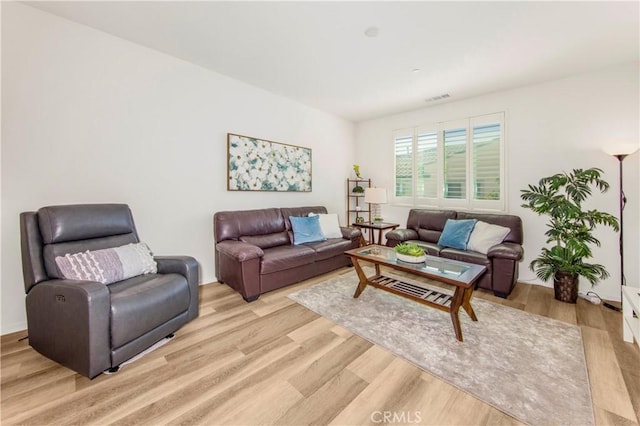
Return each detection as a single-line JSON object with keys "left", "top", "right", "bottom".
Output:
{"left": 394, "top": 113, "right": 505, "bottom": 210}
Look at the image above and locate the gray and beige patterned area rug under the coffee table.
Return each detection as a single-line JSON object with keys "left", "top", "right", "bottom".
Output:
{"left": 289, "top": 272, "right": 594, "bottom": 425}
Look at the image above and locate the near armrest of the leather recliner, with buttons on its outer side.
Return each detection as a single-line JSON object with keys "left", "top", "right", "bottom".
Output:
{"left": 26, "top": 280, "right": 111, "bottom": 378}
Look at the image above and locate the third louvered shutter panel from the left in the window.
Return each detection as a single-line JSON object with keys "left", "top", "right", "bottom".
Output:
{"left": 443, "top": 127, "right": 467, "bottom": 199}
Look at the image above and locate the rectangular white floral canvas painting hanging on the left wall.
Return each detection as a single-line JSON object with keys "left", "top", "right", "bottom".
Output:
{"left": 227, "top": 133, "right": 311, "bottom": 192}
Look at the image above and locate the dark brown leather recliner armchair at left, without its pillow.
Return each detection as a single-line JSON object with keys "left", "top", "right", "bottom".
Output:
{"left": 20, "top": 204, "right": 199, "bottom": 378}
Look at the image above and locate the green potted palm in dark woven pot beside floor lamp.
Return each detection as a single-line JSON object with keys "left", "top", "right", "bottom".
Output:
{"left": 520, "top": 168, "right": 619, "bottom": 303}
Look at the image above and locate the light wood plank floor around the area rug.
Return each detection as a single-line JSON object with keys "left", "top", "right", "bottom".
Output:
{"left": 0, "top": 268, "right": 640, "bottom": 425}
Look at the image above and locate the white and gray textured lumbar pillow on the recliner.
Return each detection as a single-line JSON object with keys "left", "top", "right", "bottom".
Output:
{"left": 55, "top": 243, "right": 158, "bottom": 284}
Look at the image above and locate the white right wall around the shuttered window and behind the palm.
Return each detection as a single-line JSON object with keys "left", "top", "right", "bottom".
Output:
{"left": 356, "top": 63, "right": 640, "bottom": 300}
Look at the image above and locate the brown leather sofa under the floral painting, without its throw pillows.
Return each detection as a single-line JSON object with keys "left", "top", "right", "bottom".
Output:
{"left": 213, "top": 206, "right": 361, "bottom": 302}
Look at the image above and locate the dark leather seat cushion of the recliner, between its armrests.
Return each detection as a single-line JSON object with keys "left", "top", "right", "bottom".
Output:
{"left": 108, "top": 274, "right": 191, "bottom": 348}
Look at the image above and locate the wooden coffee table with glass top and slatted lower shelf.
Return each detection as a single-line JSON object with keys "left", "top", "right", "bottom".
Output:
{"left": 345, "top": 245, "right": 487, "bottom": 341}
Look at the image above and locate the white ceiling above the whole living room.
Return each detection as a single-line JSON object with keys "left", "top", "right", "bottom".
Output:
{"left": 24, "top": 1, "right": 640, "bottom": 122}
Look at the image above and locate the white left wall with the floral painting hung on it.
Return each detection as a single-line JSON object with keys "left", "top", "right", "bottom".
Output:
{"left": 1, "top": 2, "right": 354, "bottom": 334}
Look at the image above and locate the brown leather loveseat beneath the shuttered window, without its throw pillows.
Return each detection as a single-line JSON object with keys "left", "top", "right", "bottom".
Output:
{"left": 386, "top": 209, "right": 523, "bottom": 298}
